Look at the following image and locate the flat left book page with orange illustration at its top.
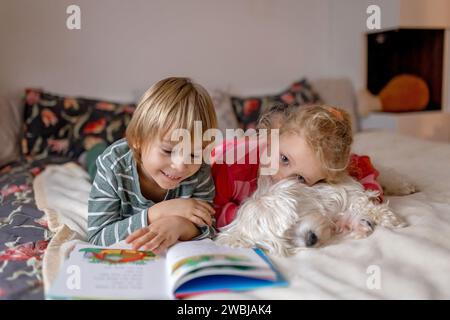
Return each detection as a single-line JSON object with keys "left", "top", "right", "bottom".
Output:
{"left": 48, "top": 245, "right": 172, "bottom": 299}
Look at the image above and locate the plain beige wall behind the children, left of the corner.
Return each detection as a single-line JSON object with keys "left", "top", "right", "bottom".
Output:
{"left": 0, "top": 0, "right": 330, "bottom": 100}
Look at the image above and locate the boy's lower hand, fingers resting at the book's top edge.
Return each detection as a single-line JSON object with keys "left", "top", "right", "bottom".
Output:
{"left": 125, "top": 216, "right": 189, "bottom": 253}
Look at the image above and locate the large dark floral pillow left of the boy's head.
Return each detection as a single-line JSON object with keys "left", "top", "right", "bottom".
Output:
{"left": 22, "top": 89, "right": 135, "bottom": 159}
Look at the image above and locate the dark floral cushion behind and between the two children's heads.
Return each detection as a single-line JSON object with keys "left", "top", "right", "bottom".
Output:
{"left": 231, "top": 79, "right": 321, "bottom": 129}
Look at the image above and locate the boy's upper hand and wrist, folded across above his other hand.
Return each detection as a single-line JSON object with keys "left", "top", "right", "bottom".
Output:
{"left": 147, "top": 198, "right": 215, "bottom": 227}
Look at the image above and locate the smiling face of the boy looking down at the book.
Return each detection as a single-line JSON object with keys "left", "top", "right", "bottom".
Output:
{"left": 141, "top": 132, "right": 201, "bottom": 189}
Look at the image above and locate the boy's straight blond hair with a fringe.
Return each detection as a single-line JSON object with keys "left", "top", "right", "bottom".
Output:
{"left": 126, "top": 77, "right": 217, "bottom": 163}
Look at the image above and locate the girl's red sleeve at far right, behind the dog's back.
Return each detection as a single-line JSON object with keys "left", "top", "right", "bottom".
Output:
{"left": 348, "top": 154, "right": 383, "bottom": 202}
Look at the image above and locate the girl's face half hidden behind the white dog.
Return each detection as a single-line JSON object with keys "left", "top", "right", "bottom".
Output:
{"left": 262, "top": 133, "right": 325, "bottom": 186}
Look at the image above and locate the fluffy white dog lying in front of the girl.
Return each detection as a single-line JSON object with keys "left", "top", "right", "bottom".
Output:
{"left": 216, "top": 176, "right": 406, "bottom": 256}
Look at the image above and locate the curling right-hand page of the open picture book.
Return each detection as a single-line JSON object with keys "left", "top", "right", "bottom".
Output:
{"left": 167, "top": 239, "right": 276, "bottom": 291}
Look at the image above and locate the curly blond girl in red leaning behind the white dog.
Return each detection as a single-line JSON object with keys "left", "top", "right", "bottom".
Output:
{"left": 212, "top": 105, "right": 382, "bottom": 235}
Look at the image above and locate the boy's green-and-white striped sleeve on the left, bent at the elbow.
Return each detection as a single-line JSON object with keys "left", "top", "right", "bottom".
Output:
{"left": 88, "top": 156, "right": 148, "bottom": 246}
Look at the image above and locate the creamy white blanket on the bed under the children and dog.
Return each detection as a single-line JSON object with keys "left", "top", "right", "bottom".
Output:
{"left": 34, "top": 132, "right": 450, "bottom": 299}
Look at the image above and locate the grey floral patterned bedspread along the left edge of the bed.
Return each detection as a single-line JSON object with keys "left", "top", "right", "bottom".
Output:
{"left": 0, "top": 158, "right": 71, "bottom": 299}
